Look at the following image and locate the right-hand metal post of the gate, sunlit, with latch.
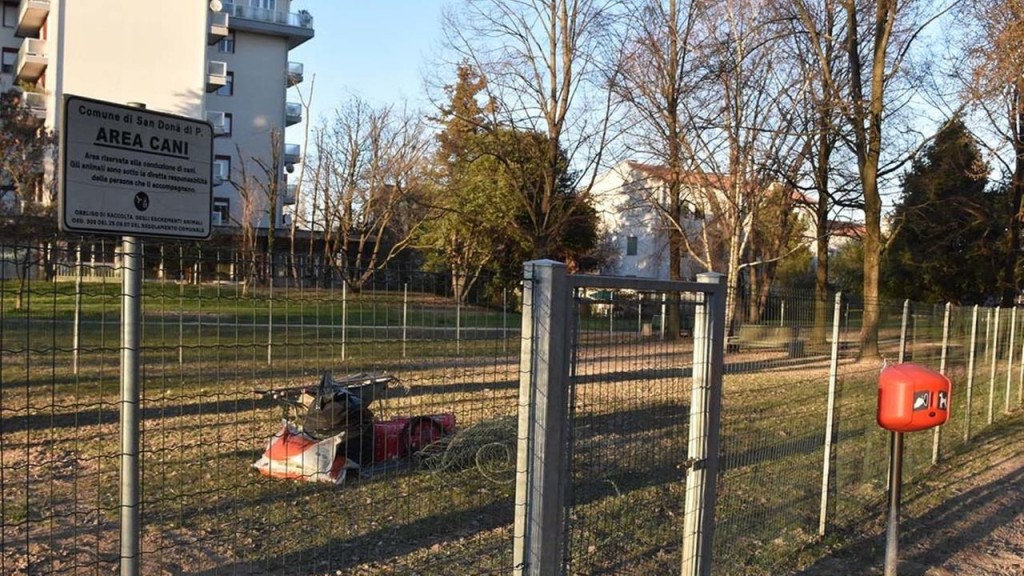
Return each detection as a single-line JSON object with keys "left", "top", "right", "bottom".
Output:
{"left": 681, "top": 273, "right": 726, "bottom": 576}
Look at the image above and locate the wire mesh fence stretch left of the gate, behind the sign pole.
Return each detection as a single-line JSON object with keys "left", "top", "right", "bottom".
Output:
{"left": 0, "top": 237, "right": 520, "bottom": 574}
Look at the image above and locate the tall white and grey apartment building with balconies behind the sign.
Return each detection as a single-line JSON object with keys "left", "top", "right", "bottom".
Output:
{"left": 0, "top": 0, "right": 313, "bottom": 230}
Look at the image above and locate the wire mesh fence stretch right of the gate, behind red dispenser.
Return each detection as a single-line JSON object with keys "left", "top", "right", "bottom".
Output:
{"left": 715, "top": 294, "right": 1024, "bottom": 575}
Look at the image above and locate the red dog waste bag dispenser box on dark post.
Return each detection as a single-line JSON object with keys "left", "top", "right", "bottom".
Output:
{"left": 878, "top": 364, "right": 949, "bottom": 433}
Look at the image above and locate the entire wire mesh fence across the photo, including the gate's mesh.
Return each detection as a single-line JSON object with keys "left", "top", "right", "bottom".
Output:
{"left": 0, "top": 235, "right": 1024, "bottom": 575}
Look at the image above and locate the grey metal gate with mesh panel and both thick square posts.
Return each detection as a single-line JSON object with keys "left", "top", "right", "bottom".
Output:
{"left": 513, "top": 260, "right": 725, "bottom": 576}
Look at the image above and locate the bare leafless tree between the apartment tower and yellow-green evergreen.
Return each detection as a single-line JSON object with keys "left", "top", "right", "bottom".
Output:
{"left": 313, "top": 98, "right": 431, "bottom": 290}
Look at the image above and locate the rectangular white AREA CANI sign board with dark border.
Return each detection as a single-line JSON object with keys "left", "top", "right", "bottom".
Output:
{"left": 58, "top": 95, "right": 213, "bottom": 239}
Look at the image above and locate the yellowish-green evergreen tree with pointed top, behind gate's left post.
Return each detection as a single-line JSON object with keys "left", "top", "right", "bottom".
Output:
{"left": 421, "top": 65, "right": 598, "bottom": 297}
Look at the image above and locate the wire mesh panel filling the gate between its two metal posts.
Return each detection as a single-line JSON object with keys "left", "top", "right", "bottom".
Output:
{"left": 565, "top": 280, "right": 700, "bottom": 574}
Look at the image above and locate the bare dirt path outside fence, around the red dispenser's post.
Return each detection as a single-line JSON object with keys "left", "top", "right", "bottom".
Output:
{"left": 798, "top": 412, "right": 1024, "bottom": 576}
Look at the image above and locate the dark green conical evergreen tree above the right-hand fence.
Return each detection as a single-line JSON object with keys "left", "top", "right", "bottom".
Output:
{"left": 884, "top": 117, "right": 1002, "bottom": 303}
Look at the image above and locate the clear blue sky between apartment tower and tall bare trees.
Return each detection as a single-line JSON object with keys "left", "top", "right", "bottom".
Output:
{"left": 289, "top": 0, "right": 445, "bottom": 132}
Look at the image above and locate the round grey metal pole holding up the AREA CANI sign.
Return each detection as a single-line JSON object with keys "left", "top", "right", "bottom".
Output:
{"left": 121, "top": 104, "right": 145, "bottom": 576}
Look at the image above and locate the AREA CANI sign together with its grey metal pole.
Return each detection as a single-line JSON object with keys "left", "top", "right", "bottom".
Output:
{"left": 57, "top": 93, "right": 213, "bottom": 576}
